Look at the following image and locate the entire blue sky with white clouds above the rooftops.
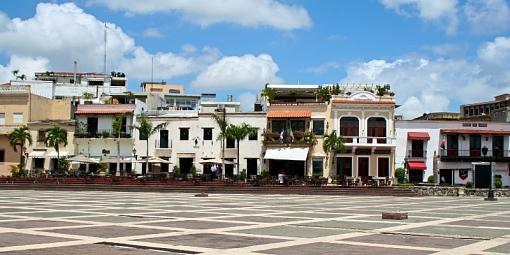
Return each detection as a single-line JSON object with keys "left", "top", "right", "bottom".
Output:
{"left": 0, "top": 0, "right": 510, "bottom": 118}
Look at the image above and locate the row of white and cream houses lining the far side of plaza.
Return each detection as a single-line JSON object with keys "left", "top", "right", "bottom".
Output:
{"left": 0, "top": 72, "right": 510, "bottom": 185}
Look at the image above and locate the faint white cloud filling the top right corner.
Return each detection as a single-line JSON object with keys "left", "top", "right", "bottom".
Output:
{"left": 464, "top": 0, "right": 510, "bottom": 34}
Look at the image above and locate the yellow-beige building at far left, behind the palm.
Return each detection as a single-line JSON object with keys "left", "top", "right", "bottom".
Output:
{"left": 0, "top": 85, "right": 71, "bottom": 175}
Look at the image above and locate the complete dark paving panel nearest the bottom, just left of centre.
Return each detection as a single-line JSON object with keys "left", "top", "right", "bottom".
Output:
{"left": 138, "top": 234, "right": 286, "bottom": 249}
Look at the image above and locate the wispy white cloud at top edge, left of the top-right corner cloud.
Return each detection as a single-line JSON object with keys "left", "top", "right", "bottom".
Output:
{"left": 379, "top": 0, "right": 459, "bottom": 34}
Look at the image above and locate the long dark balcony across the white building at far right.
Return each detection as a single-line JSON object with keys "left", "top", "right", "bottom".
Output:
{"left": 439, "top": 149, "right": 510, "bottom": 162}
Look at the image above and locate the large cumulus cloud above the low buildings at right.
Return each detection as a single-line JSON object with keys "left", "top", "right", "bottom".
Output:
{"left": 343, "top": 37, "right": 510, "bottom": 118}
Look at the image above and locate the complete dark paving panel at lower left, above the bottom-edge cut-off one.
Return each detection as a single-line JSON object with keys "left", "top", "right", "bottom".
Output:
{"left": 45, "top": 226, "right": 170, "bottom": 238}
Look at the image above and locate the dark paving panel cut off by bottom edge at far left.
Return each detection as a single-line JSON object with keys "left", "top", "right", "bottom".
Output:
{"left": 0, "top": 244, "right": 182, "bottom": 255}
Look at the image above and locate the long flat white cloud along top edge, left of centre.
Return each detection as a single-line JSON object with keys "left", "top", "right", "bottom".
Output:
{"left": 88, "top": 0, "right": 312, "bottom": 30}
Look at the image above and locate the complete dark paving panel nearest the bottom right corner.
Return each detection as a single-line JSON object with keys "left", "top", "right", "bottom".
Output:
{"left": 342, "top": 234, "right": 479, "bottom": 249}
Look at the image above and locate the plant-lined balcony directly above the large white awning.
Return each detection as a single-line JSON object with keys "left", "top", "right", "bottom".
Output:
{"left": 263, "top": 131, "right": 315, "bottom": 147}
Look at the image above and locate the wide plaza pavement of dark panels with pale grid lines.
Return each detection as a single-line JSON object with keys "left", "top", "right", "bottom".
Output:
{"left": 0, "top": 190, "right": 510, "bottom": 255}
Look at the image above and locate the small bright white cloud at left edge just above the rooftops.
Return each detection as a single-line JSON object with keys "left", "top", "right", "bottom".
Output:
{"left": 0, "top": 55, "right": 49, "bottom": 83}
